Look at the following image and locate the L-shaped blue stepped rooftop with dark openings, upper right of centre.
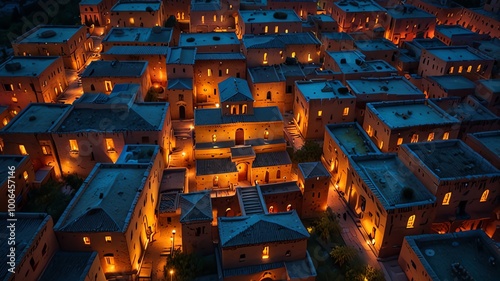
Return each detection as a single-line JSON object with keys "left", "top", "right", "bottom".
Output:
{"left": 323, "top": 50, "right": 398, "bottom": 83}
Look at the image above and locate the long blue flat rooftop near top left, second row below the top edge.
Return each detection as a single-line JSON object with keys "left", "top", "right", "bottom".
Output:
{"left": 102, "top": 26, "right": 172, "bottom": 44}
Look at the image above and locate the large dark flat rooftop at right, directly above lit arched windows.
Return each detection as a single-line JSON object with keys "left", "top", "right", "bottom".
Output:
{"left": 402, "top": 140, "right": 500, "bottom": 179}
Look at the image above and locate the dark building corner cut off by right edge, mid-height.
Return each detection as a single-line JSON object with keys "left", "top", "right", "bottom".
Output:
{"left": 465, "top": 131, "right": 500, "bottom": 169}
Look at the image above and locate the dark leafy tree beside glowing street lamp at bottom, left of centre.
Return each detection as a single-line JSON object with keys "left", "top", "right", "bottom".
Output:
{"left": 163, "top": 249, "right": 203, "bottom": 281}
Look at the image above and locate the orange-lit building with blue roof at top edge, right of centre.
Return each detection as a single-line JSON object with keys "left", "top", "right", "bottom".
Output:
{"left": 327, "top": 0, "right": 387, "bottom": 32}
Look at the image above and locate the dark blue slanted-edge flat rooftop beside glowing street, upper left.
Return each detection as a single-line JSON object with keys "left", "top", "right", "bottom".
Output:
{"left": 82, "top": 60, "right": 148, "bottom": 78}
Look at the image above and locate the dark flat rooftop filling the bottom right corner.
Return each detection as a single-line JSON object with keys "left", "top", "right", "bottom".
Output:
{"left": 405, "top": 230, "right": 500, "bottom": 280}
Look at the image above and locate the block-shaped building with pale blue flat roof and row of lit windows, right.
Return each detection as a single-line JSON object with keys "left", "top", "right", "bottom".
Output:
{"left": 363, "top": 100, "right": 460, "bottom": 152}
